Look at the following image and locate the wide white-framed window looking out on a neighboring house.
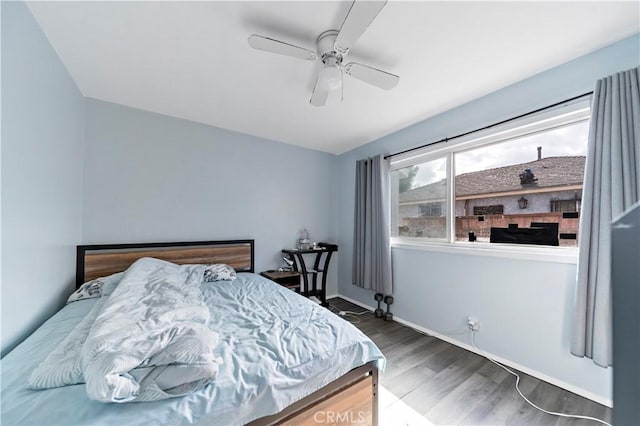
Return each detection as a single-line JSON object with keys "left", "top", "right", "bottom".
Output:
{"left": 391, "top": 101, "right": 589, "bottom": 246}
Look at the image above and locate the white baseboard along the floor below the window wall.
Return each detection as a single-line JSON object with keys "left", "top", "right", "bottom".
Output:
{"left": 327, "top": 294, "right": 613, "bottom": 408}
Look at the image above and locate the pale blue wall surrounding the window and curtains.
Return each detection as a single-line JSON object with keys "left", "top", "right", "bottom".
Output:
{"left": 335, "top": 35, "right": 640, "bottom": 401}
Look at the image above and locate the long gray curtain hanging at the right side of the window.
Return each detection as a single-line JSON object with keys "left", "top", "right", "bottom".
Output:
{"left": 571, "top": 68, "right": 640, "bottom": 367}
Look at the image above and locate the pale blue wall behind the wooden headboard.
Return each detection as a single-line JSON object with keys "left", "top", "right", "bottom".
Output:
{"left": 83, "top": 99, "right": 337, "bottom": 294}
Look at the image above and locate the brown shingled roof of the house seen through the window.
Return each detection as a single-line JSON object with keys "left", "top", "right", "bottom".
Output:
{"left": 399, "top": 156, "right": 585, "bottom": 203}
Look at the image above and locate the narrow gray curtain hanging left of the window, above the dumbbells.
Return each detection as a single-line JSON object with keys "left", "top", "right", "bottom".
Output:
{"left": 353, "top": 155, "right": 393, "bottom": 294}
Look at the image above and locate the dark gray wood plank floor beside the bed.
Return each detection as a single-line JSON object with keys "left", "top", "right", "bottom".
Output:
{"left": 329, "top": 298, "right": 611, "bottom": 426}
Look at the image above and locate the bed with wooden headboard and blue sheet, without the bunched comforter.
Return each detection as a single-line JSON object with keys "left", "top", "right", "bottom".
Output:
{"left": 0, "top": 240, "right": 385, "bottom": 425}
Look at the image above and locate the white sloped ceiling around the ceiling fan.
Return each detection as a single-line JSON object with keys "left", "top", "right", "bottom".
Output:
{"left": 29, "top": 0, "right": 640, "bottom": 154}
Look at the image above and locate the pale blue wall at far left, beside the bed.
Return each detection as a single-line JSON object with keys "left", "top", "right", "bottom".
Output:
{"left": 1, "top": 2, "right": 84, "bottom": 355}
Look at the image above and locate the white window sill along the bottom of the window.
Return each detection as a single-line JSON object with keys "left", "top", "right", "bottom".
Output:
{"left": 391, "top": 238, "right": 578, "bottom": 265}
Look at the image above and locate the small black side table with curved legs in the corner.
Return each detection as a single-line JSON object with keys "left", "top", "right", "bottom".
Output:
{"left": 282, "top": 243, "right": 338, "bottom": 307}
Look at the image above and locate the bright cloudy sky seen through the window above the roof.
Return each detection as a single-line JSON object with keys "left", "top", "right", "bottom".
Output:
{"left": 413, "top": 121, "right": 589, "bottom": 188}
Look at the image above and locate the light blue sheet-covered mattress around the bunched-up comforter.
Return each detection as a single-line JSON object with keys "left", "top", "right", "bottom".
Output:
{"left": 0, "top": 273, "right": 385, "bottom": 425}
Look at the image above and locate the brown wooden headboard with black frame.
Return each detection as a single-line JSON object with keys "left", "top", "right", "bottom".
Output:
{"left": 76, "top": 240, "right": 254, "bottom": 288}
